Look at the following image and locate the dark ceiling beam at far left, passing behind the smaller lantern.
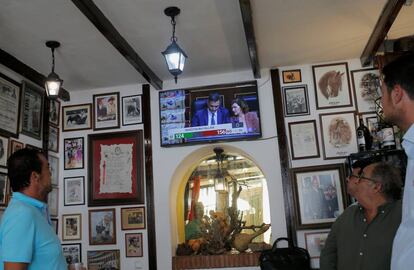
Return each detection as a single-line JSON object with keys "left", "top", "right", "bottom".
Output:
{"left": 0, "top": 49, "right": 70, "bottom": 101}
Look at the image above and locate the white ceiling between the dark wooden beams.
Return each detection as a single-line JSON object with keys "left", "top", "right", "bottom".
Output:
{"left": 0, "top": 0, "right": 414, "bottom": 91}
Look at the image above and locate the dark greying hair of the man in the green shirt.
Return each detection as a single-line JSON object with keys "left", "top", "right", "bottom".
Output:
{"left": 371, "top": 161, "right": 402, "bottom": 200}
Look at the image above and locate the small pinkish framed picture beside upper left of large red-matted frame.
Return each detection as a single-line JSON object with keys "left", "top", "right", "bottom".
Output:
{"left": 64, "top": 137, "right": 84, "bottom": 170}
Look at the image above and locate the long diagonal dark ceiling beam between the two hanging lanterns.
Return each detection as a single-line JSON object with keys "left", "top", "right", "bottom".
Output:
{"left": 72, "top": 0, "right": 162, "bottom": 90}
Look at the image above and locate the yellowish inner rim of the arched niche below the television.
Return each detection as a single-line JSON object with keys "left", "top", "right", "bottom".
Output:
{"left": 169, "top": 144, "right": 269, "bottom": 256}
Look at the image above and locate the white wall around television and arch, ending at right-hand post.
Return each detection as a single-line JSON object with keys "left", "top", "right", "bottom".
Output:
{"left": 59, "top": 71, "right": 286, "bottom": 269}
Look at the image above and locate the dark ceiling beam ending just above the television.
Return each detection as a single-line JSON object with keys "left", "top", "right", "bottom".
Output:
{"left": 239, "top": 0, "right": 260, "bottom": 79}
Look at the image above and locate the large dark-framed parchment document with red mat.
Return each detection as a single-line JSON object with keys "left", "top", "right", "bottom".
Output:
{"left": 88, "top": 130, "right": 144, "bottom": 206}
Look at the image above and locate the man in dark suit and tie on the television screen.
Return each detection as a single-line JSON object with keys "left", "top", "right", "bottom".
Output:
{"left": 191, "top": 92, "right": 230, "bottom": 127}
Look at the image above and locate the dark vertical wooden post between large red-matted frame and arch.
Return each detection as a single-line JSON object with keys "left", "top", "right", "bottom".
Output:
{"left": 141, "top": 84, "right": 157, "bottom": 270}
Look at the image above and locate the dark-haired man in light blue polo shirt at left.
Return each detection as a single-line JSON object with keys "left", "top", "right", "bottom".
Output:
{"left": 0, "top": 148, "right": 68, "bottom": 270}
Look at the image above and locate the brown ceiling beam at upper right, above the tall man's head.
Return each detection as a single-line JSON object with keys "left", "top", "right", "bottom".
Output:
{"left": 360, "top": 0, "right": 405, "bottom": 67}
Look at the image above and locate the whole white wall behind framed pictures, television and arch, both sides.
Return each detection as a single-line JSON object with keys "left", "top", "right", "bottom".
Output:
{"left": 0, "top": 55, "right": 368, "bottom": 269}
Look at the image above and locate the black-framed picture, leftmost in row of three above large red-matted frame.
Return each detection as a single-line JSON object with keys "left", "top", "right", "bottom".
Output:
{"left": 62, "top": 103, "right": 92, "bottom": 131}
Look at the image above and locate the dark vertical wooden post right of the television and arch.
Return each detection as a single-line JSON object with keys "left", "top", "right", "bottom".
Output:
{"left": 270, "top": 69, "right": 297, "bottom": 243}
